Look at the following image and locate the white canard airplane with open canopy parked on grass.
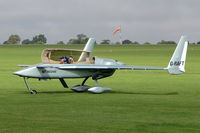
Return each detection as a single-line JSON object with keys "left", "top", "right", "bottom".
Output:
{"left": 13, "top": 36, "right": 189, "bottom": 94}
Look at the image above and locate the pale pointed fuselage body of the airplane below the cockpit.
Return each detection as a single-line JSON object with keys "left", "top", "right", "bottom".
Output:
{"left": 14, "top": 64, "right": 115, "bottom": 79}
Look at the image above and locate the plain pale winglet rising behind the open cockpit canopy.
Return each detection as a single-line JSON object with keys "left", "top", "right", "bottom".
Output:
{"left": 78, "top": 38, "right": 95, "bottom": 62}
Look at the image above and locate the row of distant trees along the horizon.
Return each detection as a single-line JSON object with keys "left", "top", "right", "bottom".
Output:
{"left": 3, "top": 34, "right": 200, "bottom": 45}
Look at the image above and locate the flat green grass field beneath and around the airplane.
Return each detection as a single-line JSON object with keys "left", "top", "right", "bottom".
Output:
{"left": 0, "top": 45, "right": 200, "bottom": 133}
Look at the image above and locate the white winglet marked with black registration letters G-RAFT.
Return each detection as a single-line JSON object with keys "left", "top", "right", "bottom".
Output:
{"left": 167, "top": 36, "right": 189, "bottom": 75}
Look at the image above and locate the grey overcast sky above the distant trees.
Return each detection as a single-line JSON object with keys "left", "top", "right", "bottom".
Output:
{"left": 0, "top": 0, "right": 200, "bottom": 44}
